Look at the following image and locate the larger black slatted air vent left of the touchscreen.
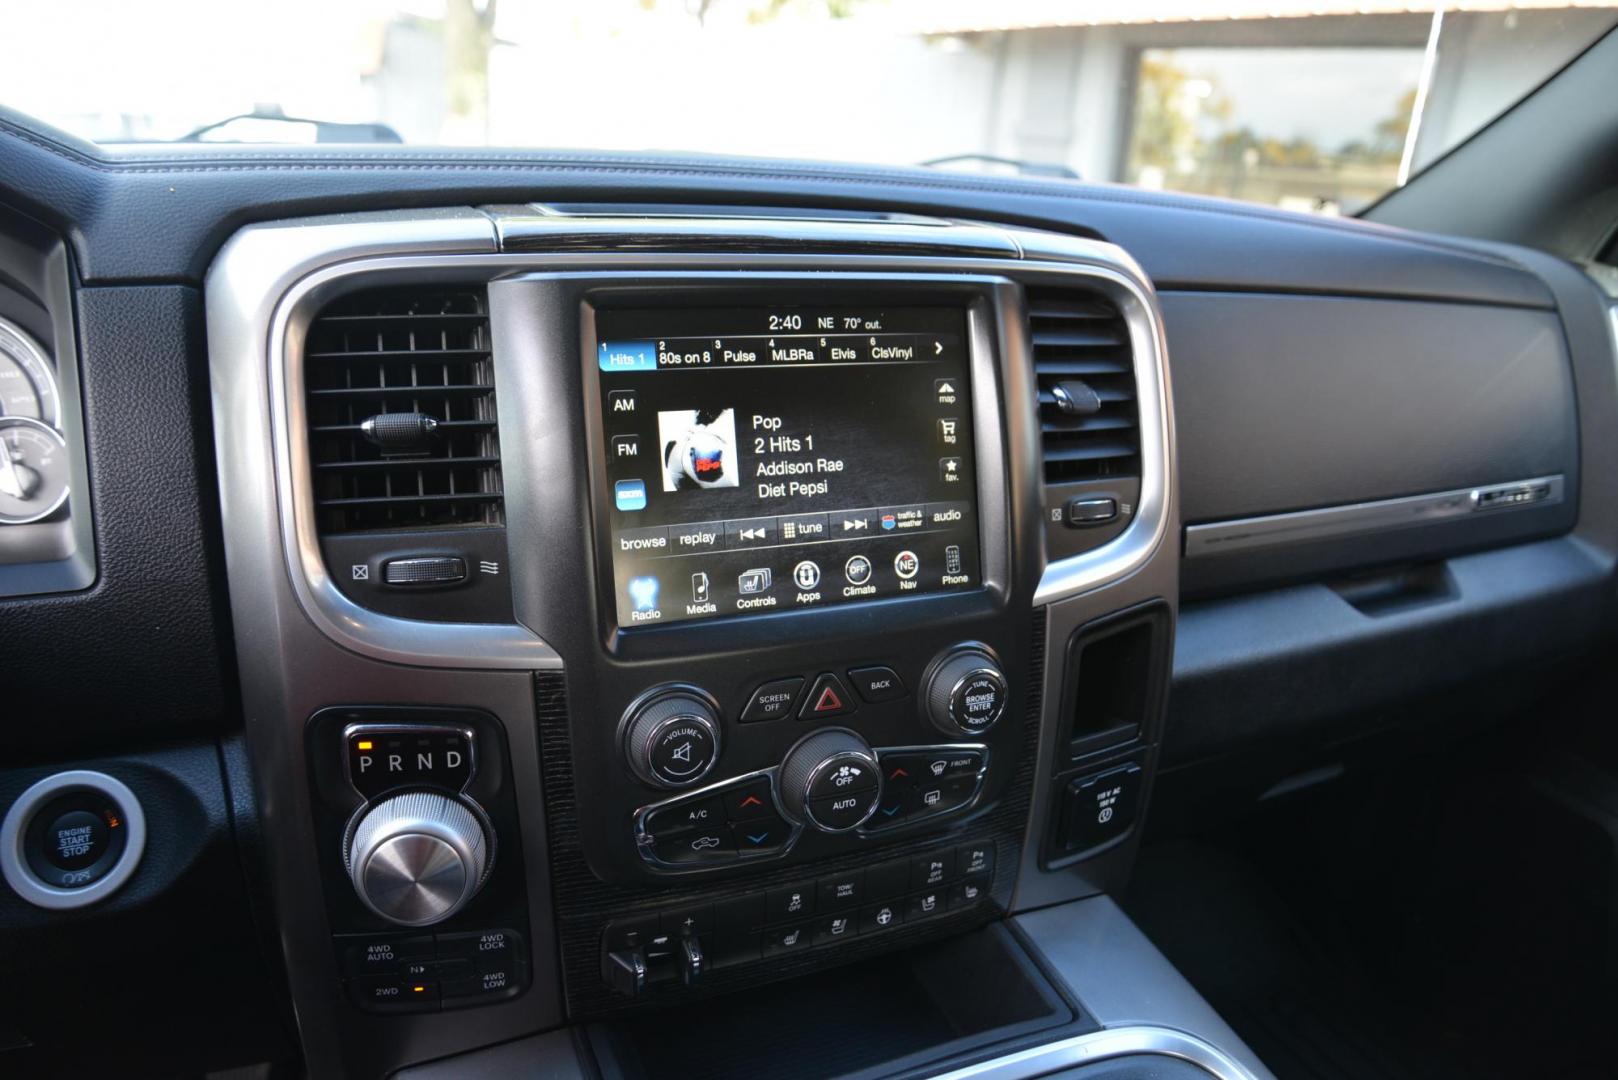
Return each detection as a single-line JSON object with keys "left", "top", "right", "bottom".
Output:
{"left": 304, "top": 288, "right": 503, "bottom": 536}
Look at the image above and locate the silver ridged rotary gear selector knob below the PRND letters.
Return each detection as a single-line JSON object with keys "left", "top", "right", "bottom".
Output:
{"left": 343, "top": 792, "right": 490, "bottom": 926}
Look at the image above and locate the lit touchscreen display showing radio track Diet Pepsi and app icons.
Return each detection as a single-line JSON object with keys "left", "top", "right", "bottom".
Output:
{"left": 595, "top": 306, "right": 981, "bottom": 627}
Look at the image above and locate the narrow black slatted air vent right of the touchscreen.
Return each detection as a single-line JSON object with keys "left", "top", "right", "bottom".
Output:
{"left": 1027, "top": 288, "right": 1141, "bottom": 484}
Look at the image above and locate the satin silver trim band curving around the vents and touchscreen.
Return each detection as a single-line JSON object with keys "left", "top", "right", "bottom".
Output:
{"left": 215, "top": 209, "right": 1173, "bottom": 670}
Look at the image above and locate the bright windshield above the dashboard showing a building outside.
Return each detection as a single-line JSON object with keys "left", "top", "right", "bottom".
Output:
{"left": 0, "top": 0, "right": 1618, "bottom": 214}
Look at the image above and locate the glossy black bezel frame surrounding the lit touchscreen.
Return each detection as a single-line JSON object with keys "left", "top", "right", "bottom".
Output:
{"left": 578, "top": 274, "right": 1016, "bottom": 654}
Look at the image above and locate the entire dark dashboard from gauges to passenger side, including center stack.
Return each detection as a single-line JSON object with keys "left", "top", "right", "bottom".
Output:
{"left": 0, "top": 107, "right": 1618, "bottom": 1077}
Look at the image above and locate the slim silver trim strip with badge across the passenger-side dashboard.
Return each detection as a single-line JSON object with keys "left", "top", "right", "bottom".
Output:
{"left": 1186, "top": 473, "right": 1565, "bottom": 559}
